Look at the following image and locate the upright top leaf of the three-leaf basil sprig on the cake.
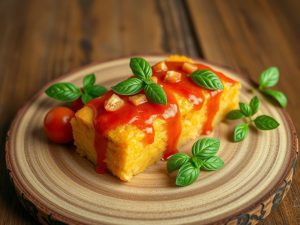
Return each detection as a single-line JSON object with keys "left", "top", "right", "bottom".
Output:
{"left": 129, "top": 58, "right": 152, "bottom": 80}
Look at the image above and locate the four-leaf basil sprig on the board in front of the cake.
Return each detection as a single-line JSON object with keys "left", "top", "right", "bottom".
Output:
{"left": 167, "top": 138, "right": 224, "bottom": 187}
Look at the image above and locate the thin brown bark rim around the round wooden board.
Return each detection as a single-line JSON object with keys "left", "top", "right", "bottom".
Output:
{"left": 6, "top": 54, "right": 298, "bottom": 224}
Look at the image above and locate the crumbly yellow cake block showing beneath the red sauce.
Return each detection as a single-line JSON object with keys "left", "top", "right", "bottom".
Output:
{"left": 71, "top": 56, "right": 240, "bottom": 181}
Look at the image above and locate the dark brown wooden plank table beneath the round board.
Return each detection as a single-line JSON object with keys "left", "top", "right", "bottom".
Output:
{"left": 0, "top": 0, "right": 300, "bottom": 225}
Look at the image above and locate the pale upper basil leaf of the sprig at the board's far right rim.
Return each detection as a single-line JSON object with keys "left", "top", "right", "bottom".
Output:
{"left": 259, "top": 67, "right": 279, "bottom": 89}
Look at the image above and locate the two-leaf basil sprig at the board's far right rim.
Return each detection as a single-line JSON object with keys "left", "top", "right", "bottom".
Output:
{"left": 258, "top": 67, "right": 287, "bottom": 108}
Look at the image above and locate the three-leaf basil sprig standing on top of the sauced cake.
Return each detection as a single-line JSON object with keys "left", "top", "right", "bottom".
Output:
{"left": 112, "top": 58, "right": 167, "bottom": 105}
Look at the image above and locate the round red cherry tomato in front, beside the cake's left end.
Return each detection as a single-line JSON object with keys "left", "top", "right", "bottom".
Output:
{"left": 44, "top": 107, "right": 74, "bottom": 144}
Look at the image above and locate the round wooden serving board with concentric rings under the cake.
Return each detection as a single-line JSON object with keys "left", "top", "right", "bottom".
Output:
{"left": 6, "top": 56, "right": 298, "bottom": 225}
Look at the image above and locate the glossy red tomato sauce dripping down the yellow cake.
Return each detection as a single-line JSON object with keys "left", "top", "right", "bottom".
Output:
{"left": 87, "top": 61, "right": 235, "bottom": 173}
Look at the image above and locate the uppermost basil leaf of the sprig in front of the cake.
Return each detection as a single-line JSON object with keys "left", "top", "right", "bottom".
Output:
{"left": 192, "top": 138, "right": 220, "bottom": 159}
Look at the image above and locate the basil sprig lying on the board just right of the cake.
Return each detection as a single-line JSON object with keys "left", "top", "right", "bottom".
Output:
{"left": 227, "top": 96, "right": 279, "bottom": 142}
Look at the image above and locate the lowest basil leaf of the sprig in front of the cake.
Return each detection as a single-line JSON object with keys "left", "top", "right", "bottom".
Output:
{"left": 176, "top": 162, "right": 200, "bottom": 187}
